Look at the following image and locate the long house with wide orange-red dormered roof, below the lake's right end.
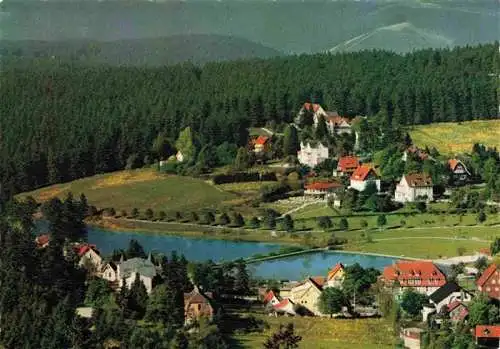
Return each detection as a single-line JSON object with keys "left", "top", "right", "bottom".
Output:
{"left": 381, "top": 260, "right": 446, "bottom": 295}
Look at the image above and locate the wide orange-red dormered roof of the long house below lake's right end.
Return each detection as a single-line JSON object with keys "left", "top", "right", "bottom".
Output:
{"left": 382, "top": 261, "right": 446, "bottom": 287}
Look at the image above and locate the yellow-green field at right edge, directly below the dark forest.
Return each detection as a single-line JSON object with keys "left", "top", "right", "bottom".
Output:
{"left": 410, "top": 120, "right": 500, "bottom": 155}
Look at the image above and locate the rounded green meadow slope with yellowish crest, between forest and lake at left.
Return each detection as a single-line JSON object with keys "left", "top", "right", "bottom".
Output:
{"left": 16, "top": 169, "right": 241, "bottom": 212}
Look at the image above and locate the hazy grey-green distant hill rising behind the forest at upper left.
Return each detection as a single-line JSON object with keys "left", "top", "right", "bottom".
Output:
{"left": 0, "top": 35, "right": 283, "bottom": 66}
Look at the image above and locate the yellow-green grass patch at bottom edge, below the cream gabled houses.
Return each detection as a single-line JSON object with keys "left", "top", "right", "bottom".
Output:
{"left": 235, "top": 315, "right": 394, "bottom": 349}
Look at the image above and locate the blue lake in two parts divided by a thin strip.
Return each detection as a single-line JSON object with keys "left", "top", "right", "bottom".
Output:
{"left": 37, "top": 222, "right": 394, "bottom": 280}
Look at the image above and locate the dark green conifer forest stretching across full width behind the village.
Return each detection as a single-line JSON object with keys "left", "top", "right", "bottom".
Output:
{"left": 0, "top": 43, "right": 498, "bottom": 196}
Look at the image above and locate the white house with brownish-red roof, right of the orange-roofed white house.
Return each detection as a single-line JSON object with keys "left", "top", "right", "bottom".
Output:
{"left": 394, "top": 173, "right": 433, "bottom": 203}
